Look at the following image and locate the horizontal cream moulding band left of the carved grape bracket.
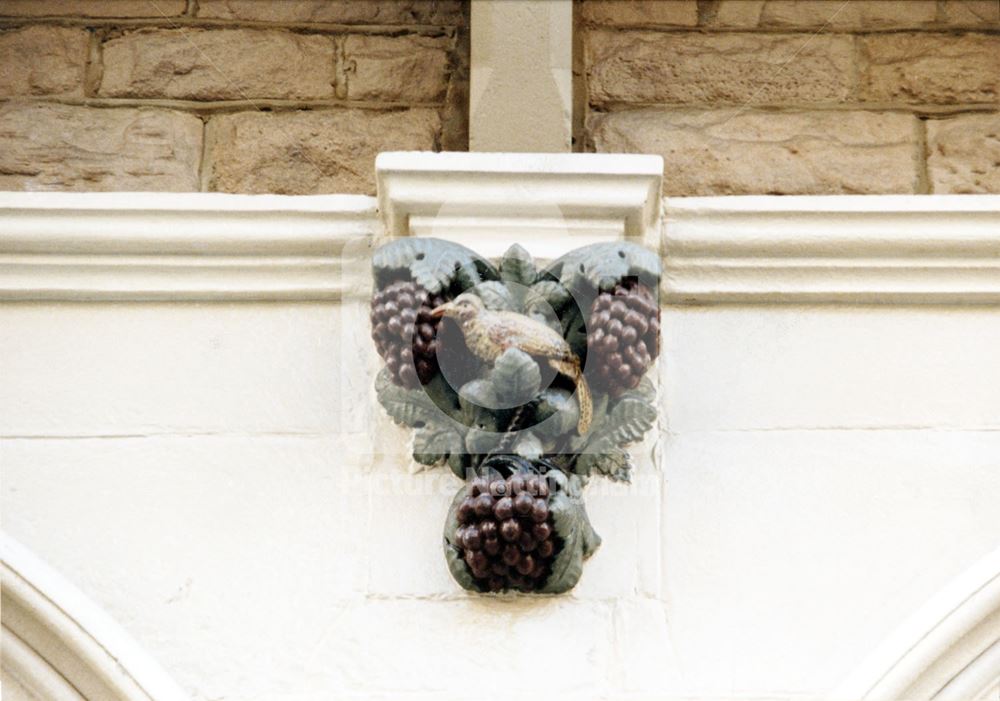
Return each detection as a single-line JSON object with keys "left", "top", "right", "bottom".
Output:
{"left": 0, "top": 192, "right": 378, "bottom": 301}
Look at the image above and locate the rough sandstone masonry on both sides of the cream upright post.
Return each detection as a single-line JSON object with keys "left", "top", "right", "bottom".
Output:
{"left": 0, "top": 0, "right": 1000, "bottom": 196}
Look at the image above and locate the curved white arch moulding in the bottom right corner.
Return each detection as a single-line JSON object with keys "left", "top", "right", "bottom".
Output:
{"left": 834, "top": 548, "right": 1000, "bottom": 701}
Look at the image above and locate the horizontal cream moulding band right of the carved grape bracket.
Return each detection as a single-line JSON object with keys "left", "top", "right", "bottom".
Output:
{"left": 661, "top": 195, "right": 1000, "bottom": 304}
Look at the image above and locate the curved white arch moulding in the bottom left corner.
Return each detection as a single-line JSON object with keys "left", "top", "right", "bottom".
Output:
{"left": 0, "top": 534, "right": 188, "bottom": 701}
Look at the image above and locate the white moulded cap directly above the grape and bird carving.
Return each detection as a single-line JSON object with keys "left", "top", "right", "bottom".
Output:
{"left": 375, "top": 152, "right": 663, "bottom": 259}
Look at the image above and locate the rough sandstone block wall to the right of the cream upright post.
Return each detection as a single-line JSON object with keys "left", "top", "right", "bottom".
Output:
{"left": 576, "top": 0, "right": 1000, "bottom": 196}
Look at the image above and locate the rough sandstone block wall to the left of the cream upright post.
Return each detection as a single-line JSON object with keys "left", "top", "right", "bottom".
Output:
{"left": 0, "top": 0, "right": 469, "bottom": 194}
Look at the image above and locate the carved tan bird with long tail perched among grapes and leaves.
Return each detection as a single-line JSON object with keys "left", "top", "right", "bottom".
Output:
{"left": 432, "top": 293, "right": 594, "bottom": 436}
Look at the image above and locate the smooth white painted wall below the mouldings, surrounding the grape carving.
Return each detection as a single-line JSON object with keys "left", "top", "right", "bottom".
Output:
{"left": 0, "top": 178, "right": 1000, "bottom": 701}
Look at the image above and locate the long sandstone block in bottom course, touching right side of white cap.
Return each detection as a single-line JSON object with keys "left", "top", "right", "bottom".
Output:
{"left": 590, "top": 108, "right": 917, "bottom": 196}
